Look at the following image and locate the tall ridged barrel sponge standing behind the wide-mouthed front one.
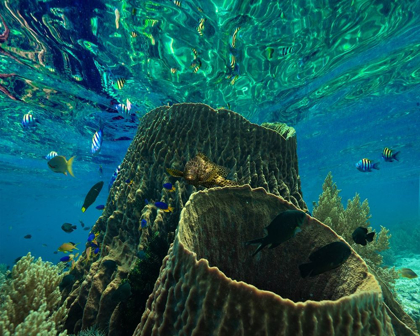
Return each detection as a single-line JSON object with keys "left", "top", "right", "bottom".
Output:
{"left": 63, "top": 104, "right": 307, "bottom": 335}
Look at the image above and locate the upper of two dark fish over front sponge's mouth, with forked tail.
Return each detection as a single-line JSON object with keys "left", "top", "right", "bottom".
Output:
{"left": 245, "top": 210, "right": 306, "bottom": 256}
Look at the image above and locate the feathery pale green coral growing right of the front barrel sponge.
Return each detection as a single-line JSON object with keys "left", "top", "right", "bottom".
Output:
{"left": 312, "top": 172, "right": 416, "bottom": 330}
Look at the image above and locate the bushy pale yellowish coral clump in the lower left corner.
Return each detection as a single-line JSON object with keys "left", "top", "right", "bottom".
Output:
{"left": 0, "top": 253, "right": 67, "bottom": 336}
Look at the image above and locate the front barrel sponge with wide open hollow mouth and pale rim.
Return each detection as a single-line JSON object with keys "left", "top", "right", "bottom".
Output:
{"left": 134, "top": 186, "right": 395, "bottom": 336}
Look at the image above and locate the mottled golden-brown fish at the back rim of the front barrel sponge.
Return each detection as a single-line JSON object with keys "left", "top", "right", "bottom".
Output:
{"left": 166, "top": 153, "right": 237, "bottom": 188}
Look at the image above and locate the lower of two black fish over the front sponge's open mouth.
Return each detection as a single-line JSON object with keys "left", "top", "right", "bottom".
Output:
{"left": 299, "top": 241, "right": 351, "bottom": 278}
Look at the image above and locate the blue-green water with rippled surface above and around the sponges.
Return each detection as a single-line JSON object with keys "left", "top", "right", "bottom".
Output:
{"left": 0, "top": 0, "right": 420, "bottom": 261}
